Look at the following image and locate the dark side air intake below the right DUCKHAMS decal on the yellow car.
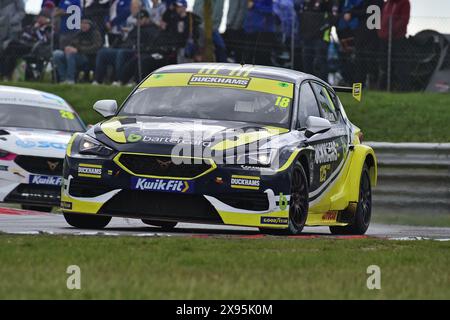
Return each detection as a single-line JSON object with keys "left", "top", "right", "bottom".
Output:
{"left": 214, "top": 192, "right": 269, "bottom": 211}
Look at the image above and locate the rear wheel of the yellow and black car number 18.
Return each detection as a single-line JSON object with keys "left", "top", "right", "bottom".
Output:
{"left": 330, "top": 166, "right": 372, "bottom": 235}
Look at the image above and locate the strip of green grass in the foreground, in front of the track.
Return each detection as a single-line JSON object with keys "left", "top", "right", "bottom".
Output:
{"left": 0, "top": 235, "right": 450, "bottom": 299}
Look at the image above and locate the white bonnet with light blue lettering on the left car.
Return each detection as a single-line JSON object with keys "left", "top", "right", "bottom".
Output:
{"left": 0, "top": 127, "right": 72, "bottom": 159}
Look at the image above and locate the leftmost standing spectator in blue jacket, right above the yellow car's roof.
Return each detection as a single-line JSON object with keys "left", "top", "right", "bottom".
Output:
{"left": 244, "top": 0, "right": 276, "bottom": 66}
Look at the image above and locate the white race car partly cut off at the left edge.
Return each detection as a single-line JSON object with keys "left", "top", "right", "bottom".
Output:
{"left": 0, "top": 86, "right": 86, "bottom": 212}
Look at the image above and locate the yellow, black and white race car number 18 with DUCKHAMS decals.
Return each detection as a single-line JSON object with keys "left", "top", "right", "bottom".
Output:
{"left": 61, "top": 64, "right": 377, "bottom": 234}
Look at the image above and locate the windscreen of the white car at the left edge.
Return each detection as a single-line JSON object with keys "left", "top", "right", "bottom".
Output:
{"left": 0, "top": 104, "right": 85, "bottom": 132}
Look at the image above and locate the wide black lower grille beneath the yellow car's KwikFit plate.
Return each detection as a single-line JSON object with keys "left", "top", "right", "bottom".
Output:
{"left": 101, "top": 190, "right": 222, "bottom": 223}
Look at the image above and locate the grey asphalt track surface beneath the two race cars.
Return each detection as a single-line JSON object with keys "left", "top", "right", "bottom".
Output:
{"left": 0, "top": 207, "right": 450, "bottom": 241}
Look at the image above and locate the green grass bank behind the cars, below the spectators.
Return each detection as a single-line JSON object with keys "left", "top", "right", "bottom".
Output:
{"left": 2, "top": 82, "right": 450, "bottom": 142}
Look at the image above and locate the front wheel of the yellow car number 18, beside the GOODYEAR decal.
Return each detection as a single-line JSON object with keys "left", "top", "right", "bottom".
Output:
{"left": 260, "top": 163, "right": 309, "bottom": 235}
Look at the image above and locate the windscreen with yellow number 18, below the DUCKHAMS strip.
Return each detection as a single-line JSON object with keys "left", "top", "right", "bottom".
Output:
{"left": 119, "top": 86, "right": 292, "bottom": 128}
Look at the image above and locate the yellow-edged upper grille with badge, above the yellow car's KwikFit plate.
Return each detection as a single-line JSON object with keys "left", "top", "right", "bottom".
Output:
{"left": 117, "top": 153, "right": 214, "bottom": 179}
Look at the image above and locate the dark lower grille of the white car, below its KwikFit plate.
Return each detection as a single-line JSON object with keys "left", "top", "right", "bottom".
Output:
{"left": 5, "top": 184, "right": 61, "bottom": 206}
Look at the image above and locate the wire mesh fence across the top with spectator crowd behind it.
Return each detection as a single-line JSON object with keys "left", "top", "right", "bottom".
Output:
{"left": 0, "top": 0, "right": 450, "bottom": 91}
